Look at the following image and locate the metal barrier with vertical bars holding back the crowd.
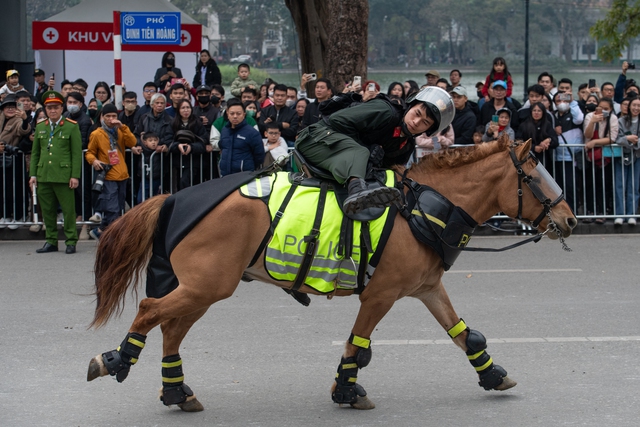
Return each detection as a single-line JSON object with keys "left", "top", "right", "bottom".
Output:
{"left": 0, "top": 144, "right": 640, "bottom": 228}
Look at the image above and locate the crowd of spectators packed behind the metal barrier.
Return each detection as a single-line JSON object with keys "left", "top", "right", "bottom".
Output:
{"left": 0, "top": 50, "right": 640, "bottom": 239}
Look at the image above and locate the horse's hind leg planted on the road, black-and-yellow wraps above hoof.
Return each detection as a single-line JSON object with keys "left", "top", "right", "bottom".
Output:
{"left": 160, "top": 307, "right": 208, "bottom": 412}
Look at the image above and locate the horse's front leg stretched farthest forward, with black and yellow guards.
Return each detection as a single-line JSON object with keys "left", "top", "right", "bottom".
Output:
{"left": 418, "top": 282, "right": 517, "bottom": 390}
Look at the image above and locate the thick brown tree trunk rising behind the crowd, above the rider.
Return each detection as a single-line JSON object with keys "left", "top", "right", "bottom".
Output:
{"left": 285, "top": 0, "right": 369, "bottom": 93}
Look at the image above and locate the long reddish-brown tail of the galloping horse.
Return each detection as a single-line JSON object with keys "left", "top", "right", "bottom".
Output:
{"left": 89, "top": 194, "right": 169, "bottom": 328}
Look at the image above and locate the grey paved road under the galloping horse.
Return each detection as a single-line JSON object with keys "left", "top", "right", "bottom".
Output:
{"left": 0, "top": 235, "right": 640, "bottom": 427}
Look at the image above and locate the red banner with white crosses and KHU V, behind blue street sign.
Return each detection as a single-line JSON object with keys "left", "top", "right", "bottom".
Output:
{"left": 31, "top": 21, "right": 202, "bottom": 52}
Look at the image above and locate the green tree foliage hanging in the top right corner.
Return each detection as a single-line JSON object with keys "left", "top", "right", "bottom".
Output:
{"left": 590, "top": 0, "right": 640, "bottom": 62}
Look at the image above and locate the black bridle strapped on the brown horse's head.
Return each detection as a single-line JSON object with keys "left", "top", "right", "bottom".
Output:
{"left": 509, "top": 147, "right": 571, "bottom": 251}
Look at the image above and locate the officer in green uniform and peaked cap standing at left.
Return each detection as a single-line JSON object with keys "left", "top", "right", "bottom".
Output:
{"left": 29, "top": 90, "right": 82, "bottom": 254}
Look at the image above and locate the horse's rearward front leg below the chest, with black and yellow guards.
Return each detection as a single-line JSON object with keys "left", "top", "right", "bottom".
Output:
{"left": 331, "top": 289, "right": 397, "bottom": 409}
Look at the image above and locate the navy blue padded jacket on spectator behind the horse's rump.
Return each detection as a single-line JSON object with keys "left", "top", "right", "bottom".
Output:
{"left": 219, "top": 120, "right": 264, "bottom": 176}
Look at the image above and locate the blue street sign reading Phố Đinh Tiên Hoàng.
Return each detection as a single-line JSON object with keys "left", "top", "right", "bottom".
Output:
{"left": 120, "top": 12, "right": 181, "bottom": 45}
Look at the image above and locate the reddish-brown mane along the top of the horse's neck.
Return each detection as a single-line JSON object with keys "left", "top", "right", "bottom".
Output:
{"left": 410, "top": 135, "right": 518, "bottom": 173}
